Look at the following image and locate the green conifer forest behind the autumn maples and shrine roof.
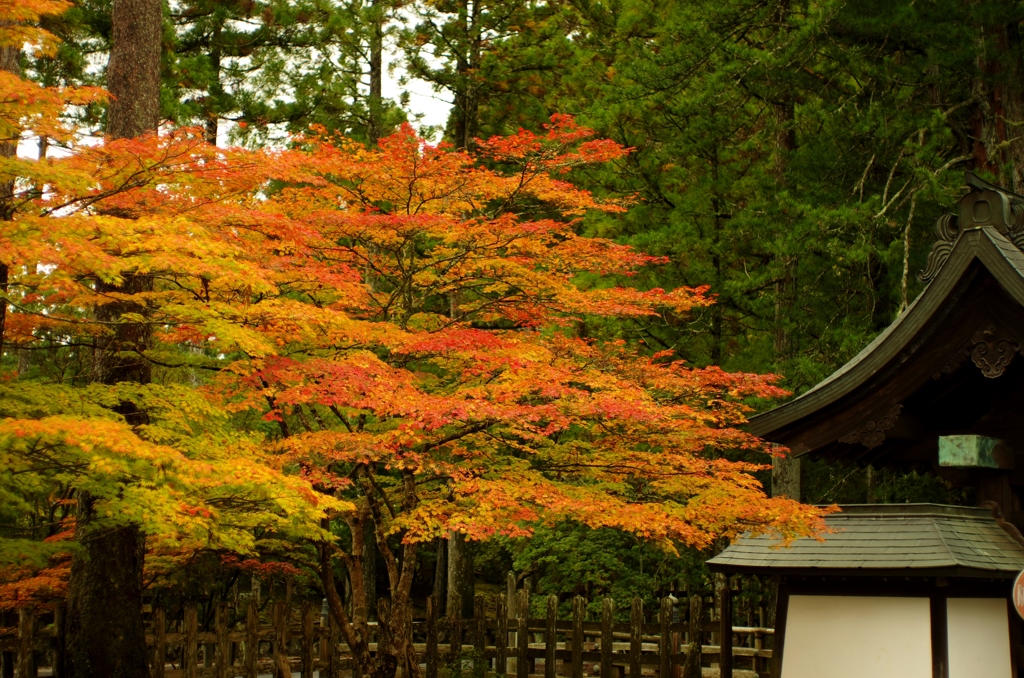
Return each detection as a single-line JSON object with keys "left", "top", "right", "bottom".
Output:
{"left": 3, "top": 0, "right": 1024, "bottom": 667}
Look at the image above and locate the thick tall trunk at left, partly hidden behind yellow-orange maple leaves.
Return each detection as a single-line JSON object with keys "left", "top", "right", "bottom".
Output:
{"left": 67, "top": 0, "right": 163, "bottom": 678}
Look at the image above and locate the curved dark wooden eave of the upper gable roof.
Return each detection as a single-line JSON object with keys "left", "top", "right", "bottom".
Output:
{"left": 749, "top": 225, "right": 1024, "bottom": 462}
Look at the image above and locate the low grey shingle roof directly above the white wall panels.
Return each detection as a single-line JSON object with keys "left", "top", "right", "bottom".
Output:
{"left": 708, "top": 504, "right": 1024, "bottom": 579}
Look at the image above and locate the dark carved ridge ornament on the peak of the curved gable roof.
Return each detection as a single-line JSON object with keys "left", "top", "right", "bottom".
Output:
{"left": 918, "top": 172, "right": 1024, "bottom": 285}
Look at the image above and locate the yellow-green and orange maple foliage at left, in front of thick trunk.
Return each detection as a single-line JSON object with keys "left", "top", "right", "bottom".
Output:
{"left": 0, "top": 0, "right": 335, "bottom": 643}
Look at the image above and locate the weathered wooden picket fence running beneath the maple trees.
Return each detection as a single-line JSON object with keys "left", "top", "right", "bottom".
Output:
{"left": 0, "top": 587, "right": 773, "bottom": 678}
